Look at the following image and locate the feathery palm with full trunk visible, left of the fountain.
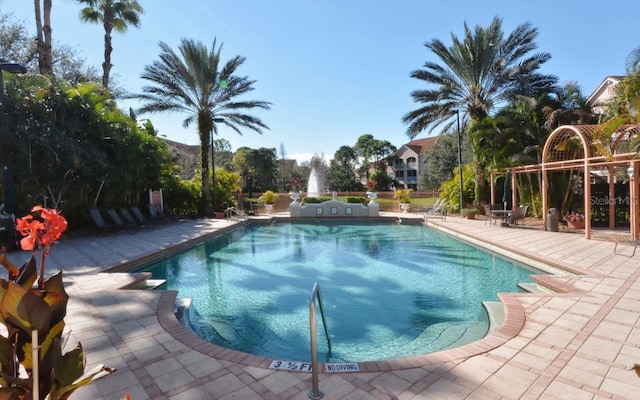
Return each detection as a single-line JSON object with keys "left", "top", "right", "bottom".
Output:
{"left": 136, "top": 39, "right": 271, "bottom": 213}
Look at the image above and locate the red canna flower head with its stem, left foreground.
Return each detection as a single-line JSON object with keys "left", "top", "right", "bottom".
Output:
{"left": 16, "top": 206, "right": 67, "bottom": 290}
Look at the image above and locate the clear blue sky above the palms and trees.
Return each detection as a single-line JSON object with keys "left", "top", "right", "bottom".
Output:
{"left": 0, "top": 0, "right": 640, "bottom": 161}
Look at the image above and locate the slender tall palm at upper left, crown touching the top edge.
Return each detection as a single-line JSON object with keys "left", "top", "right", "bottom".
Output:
{"left": 78, "top": 0, "right": 144, "bottom": 88}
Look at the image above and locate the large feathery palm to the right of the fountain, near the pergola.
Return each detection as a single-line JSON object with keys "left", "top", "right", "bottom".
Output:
{"left": 403, "top": 17, "right": 557, "bottom": 200}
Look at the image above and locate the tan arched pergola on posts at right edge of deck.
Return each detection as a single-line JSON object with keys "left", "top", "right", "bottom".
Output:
{"left": 491, "top": 124, "right": 640, "bottom": 240}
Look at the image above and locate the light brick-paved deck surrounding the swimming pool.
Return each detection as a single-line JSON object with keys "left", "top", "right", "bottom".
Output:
{"left": 9, "top": 213, "right": 640, "bottom": 400}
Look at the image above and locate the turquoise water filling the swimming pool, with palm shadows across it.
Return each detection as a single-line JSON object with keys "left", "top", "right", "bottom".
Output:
{"left": 145, "top": 222, "right": 535, "bottom": 362}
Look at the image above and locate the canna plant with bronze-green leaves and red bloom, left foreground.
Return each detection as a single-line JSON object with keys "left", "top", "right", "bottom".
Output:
{"left": 0, "top": 207, "right": 115, "bottom": 400}
